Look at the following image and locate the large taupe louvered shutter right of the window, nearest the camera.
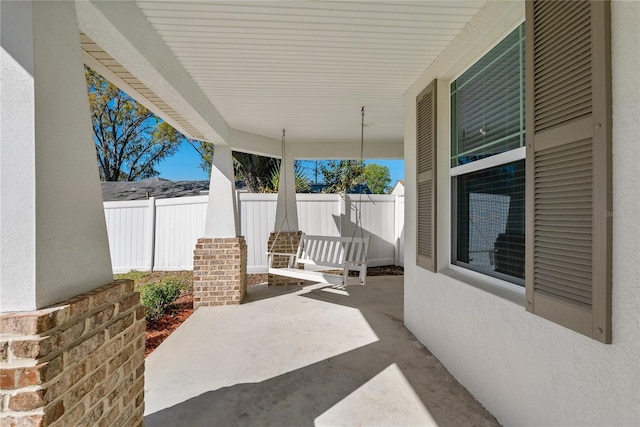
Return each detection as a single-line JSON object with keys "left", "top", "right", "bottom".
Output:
{"left": 526, "top": 1, "right": 611, "bottom": 343}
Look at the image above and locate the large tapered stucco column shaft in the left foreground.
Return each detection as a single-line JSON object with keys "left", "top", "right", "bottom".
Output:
{"left": 0, "top": 1, "right": 113, "bottom": 312}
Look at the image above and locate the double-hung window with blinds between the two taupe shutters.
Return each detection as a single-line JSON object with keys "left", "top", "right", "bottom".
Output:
{"left": 451, "top": 24, "right": 525, "bottom": 286}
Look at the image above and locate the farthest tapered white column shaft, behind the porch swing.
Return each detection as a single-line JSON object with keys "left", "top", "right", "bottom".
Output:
{"left": 274, "top": 145, "right": 298, "bottom": 233}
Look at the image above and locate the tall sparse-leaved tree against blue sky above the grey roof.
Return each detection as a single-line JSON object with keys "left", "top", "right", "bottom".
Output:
{"left": 85, "top": 67, "right": 184, "bottom": 181}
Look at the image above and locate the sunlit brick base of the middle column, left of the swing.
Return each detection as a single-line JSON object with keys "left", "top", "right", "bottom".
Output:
{"left": 193, "top": 236, "right": 247, "bottom": 308}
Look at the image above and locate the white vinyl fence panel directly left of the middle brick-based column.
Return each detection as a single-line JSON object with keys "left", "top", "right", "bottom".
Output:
{"left": 154, "top": 196, "right": 208, "bottom": 270}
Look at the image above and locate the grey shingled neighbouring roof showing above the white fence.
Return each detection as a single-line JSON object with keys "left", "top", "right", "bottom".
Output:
{"left": 101, "top": 178, "right": 209, "bottom": 202}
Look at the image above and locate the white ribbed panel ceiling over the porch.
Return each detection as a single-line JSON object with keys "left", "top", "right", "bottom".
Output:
{"left": 136, "top": 0, "right": 485, "bottom": 143}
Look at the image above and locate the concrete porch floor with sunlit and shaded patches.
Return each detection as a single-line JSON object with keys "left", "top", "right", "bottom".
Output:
{"left": 145, "top": 276, "right": 498, "bottom": 427}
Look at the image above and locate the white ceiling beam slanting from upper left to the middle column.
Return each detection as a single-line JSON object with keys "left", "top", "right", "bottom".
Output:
{"left": 76, "top": 0, "right": 280, "bottom": 156}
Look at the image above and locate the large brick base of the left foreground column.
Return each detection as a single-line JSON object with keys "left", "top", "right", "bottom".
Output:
{"left": 0, "top": 280, "right": 145, "bottom": 426}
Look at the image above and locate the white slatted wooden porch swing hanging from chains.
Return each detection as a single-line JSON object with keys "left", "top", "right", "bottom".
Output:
{"left": 267, "top": 234, "right": 370, "bottom": 286}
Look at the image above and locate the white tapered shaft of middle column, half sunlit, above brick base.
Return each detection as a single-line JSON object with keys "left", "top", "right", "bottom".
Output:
{"left": 204, "top": 145, "right": 240, "bottom": 238}
